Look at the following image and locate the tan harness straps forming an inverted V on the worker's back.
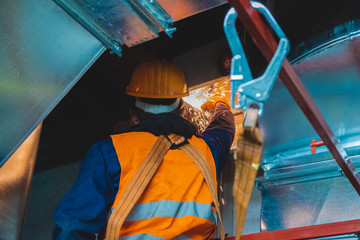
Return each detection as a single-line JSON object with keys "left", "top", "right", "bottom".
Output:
{"left": 105, "top": 134, "right": 225, "bottom": 240}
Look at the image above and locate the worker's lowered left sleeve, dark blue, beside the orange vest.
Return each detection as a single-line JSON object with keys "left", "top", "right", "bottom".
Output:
{"left": 53, "top": 139, "right": 120, "bottom": 240}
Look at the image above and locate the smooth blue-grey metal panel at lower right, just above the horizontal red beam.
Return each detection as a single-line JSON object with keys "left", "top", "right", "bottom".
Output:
{"left": 261, "top": 177, "right": 360, "bottom": 231}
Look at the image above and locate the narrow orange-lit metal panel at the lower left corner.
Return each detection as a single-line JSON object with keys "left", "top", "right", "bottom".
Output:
{"left": 0, "top": 124, "right": 42, "bottom": 240}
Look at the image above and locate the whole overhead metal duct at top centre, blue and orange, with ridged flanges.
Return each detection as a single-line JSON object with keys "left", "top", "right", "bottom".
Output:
{"left": 55, "top": 0, "right": 226, "bottom": 56}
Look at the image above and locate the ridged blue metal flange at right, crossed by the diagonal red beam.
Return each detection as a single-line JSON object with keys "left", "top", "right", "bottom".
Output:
{"left": 257, "top": 134, "right": 360, "bottom": 189}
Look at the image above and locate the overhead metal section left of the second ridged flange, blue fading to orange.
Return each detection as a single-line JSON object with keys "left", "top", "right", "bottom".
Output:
{"left": 56, "top": 0, "right": 158, "bottom": 50}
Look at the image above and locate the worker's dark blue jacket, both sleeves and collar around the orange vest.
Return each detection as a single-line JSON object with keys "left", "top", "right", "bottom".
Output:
{"left": 53, "top": 104, "right": 235, "bottom": 240}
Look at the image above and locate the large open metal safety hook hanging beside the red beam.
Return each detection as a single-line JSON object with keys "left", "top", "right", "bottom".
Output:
{"left": 224, "top": 1, "right": 290, "bottom": 116}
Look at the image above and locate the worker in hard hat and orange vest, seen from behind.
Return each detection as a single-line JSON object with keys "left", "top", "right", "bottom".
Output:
{"left": 53, "top": 61, "right": 235, "bottom": 239}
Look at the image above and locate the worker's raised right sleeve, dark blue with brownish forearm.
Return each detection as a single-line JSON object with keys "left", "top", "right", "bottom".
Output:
{"left": 200, "top": 104, "right": 235, "bottom": 176}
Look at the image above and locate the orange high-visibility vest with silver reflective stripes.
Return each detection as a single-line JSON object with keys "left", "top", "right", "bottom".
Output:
{"left": 111, "top": 132, "right": 217, "bottom": 240}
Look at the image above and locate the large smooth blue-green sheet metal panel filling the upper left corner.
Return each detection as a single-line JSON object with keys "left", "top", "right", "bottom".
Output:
{"left": 0, "top": 0, "right": 105, "bottom": 166}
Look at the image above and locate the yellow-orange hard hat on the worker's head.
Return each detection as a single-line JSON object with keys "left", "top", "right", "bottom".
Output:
{"left": 126, "top": 61, "right": 189, "bottom": 98}
